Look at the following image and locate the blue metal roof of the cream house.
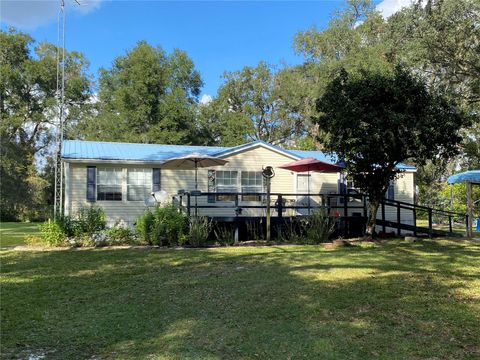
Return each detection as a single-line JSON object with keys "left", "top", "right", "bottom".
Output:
{"left": 62, "top": 140, "right": 415, "bottom": 170}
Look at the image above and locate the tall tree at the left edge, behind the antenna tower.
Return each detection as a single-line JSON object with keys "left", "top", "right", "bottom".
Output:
{"left": 0, "top": 29, "right": 91, "bottom": 219}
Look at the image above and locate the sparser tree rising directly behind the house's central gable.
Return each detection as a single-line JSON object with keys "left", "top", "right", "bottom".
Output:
{"left": 201, "top": 62, "right": 304, "bottom": 145}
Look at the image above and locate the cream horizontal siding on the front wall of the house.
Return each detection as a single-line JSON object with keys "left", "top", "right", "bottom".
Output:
{"left": 65, "top": 145, "right": 413, "bottom": 231}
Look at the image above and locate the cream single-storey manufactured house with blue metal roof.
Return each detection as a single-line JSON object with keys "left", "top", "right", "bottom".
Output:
{"left": 62, "top": 140, "right": 416, "bottom": 229}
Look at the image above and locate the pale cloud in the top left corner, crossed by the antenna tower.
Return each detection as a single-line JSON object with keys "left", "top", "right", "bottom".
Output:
{"left": 0, "top": 0, "right": 102, "bottom": 29}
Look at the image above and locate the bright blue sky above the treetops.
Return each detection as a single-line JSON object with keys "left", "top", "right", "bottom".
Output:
{"left": 0, "top": 0, "right": 406, "bottom": 99}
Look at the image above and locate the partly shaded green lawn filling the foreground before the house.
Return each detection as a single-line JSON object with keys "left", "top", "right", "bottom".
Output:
{"left": 1, "top": 240, "right": 480, "bottom": 359}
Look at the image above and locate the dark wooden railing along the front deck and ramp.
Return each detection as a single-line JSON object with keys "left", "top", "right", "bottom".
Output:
{"left": 173, "top": 191, "right": 468, "bottom": 237}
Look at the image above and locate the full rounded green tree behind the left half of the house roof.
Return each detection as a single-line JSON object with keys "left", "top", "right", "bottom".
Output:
{"left": 80, "top": 41, "right": 202, "bottom": 144}
